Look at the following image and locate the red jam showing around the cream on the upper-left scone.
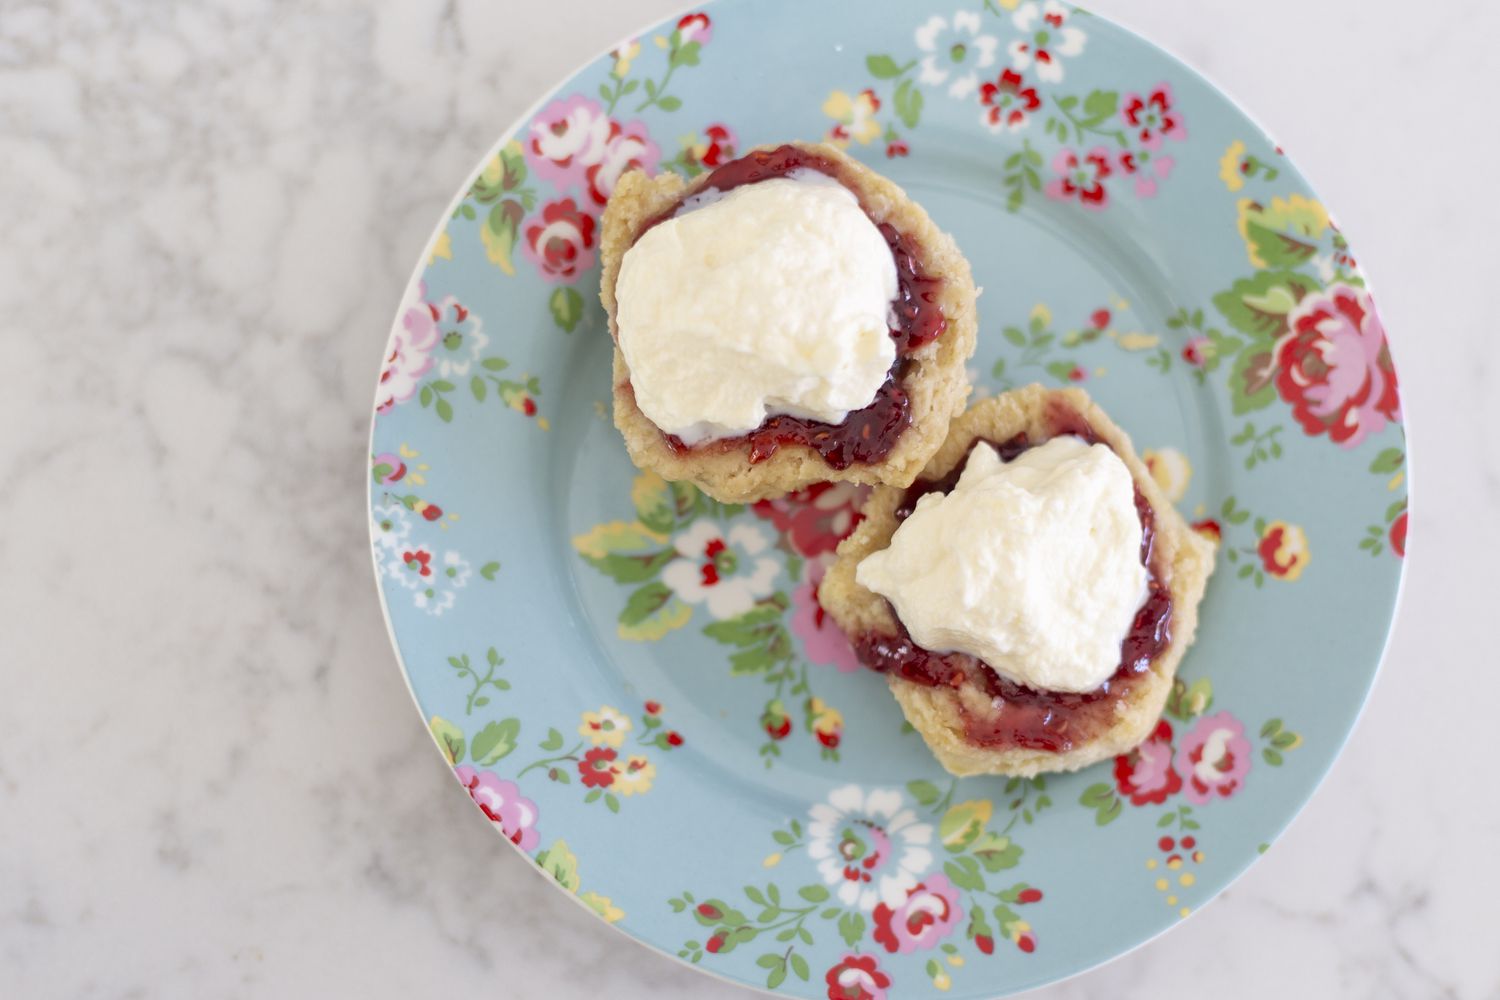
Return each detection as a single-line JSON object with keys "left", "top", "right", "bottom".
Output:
{"left": 636, "top": 145, "right": 948, "bottom": 469}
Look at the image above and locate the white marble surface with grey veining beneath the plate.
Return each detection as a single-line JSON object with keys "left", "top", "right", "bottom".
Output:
{"left": 0, "top": 0, "right": 1500, "bottom": 1000}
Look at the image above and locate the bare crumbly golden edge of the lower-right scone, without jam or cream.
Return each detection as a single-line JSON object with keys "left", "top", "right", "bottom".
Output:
{"left": 818, "top": 385, "right": 1214, "bottom": 777}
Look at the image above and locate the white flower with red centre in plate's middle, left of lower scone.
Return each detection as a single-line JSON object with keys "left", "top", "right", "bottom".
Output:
{"left": 662, "top": 519, "right": 779, "bottom": 621}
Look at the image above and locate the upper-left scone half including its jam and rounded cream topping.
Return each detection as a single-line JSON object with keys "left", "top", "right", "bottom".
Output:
{"left": 600, "top": 142, "right": 977, "bottom": 502}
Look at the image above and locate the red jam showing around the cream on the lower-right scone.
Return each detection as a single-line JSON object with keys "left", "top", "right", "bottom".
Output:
{"left": 854, "top": 406, "right": 1172, "bottom": 753}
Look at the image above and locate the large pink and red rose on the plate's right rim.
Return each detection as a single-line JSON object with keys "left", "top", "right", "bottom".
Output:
{"left": 1277, "top": 282, "right": 1401, "bottom": 448}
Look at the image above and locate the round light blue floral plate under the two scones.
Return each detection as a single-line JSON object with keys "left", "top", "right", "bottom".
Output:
{"left": 371, "top": 0, "right": 1407, "bottom": 997}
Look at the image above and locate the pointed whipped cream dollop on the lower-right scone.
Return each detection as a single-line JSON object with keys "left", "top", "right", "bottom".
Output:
{"left": 855, "top": 436, "right": 1146, "bottom": 691}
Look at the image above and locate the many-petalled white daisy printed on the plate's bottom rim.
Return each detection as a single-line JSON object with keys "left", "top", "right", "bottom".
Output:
{"left": 807, "top": 784, "right": 933, "bottom": 912}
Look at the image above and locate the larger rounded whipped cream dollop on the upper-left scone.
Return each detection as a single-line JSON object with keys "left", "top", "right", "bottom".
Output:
{"left": 615, "top": 169, "right": 897, "bottom": 445}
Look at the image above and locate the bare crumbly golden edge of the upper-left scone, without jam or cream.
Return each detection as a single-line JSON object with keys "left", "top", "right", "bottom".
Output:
{"left": 599, "top": 142, "right": 978, "bottom": 504}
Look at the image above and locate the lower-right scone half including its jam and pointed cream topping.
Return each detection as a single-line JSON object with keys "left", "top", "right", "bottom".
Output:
{"left": 819, "top": 385, "right": 1214, "bottom": 777}
